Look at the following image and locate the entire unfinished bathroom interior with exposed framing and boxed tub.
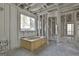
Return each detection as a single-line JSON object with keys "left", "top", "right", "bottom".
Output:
{"left": 0, "top": 3, "right": 79, "bottom": 56}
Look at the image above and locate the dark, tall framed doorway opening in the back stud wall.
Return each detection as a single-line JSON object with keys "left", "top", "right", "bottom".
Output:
{"left": 48, "top": 17, "right": 57, "bottom": 40}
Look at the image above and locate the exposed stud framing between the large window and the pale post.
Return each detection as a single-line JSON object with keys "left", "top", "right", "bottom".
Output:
{"left": 38, "top": 14, "right": 57, "bottom": 40}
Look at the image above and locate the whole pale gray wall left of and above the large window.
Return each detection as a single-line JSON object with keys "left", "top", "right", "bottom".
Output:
{"left": 0, "top": 3, "right": 35, "bottom": 49}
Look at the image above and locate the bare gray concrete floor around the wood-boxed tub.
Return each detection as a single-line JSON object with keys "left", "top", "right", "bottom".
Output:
{"left": 4, "top": 41, "right": 79, "bottom": 56}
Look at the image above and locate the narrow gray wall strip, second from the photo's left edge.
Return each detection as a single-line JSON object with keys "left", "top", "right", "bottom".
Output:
{"left": 4, "top": 4, "right": 10, "bottom": 48}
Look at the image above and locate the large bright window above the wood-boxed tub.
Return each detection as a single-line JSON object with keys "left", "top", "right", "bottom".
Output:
{"left": 20, "top": 14, "right": 35, "bottom": 31}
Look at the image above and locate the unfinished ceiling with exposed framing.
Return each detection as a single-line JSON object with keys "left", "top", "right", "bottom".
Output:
{"left": 15, "top": 3, "right": 74, "bottom": 14}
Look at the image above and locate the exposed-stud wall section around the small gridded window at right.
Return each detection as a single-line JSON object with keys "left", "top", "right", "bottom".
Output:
{"left": 61, "top": 13, "right": 75, "bottom": 36}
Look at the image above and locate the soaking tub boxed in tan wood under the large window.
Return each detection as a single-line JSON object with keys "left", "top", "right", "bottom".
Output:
{"left": 21, "top": 37, "right": 48, "bottom": 51}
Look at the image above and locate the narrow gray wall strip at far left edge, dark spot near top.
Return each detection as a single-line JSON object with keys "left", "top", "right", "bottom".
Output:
{"left": 0, "top": 4, "right": 5, "bottom": 40}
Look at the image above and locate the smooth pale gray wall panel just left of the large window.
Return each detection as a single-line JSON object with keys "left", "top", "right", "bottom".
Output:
{"left": 10, "top": 6, "right": 18, "bottom": 49}
